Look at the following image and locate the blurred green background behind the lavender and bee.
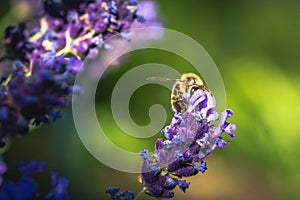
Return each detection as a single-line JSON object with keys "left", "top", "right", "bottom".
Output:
{"left": 0, "top": 0, "right": 300, "bottom": 200}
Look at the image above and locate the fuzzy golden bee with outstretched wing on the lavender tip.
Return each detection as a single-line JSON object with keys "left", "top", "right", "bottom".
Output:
{"left": 147, "top": 73, "right": 210, "bottom": 113}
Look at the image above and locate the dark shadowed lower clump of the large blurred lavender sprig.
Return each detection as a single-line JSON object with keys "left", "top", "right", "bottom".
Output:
{"left": 0, "top": 56, "right": 81, "bottom": 141}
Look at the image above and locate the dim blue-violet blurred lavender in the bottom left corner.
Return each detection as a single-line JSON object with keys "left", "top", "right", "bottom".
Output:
{"left": 0, "top": 159, "right": 70, "bottom": 200}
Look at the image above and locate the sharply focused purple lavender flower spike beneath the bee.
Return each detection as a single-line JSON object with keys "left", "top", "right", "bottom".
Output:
{"left": 140, "top": 89, "right": 236, "bottom": 198}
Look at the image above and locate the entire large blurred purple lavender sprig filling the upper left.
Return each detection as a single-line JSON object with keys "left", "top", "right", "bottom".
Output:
{"left": 0, "top": 0, "right": 155, "bottom": 146}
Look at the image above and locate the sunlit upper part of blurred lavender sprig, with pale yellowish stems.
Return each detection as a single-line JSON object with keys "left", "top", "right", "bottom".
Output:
{"left": 4, "top": 0, "right": 144, "bottom": 62}
